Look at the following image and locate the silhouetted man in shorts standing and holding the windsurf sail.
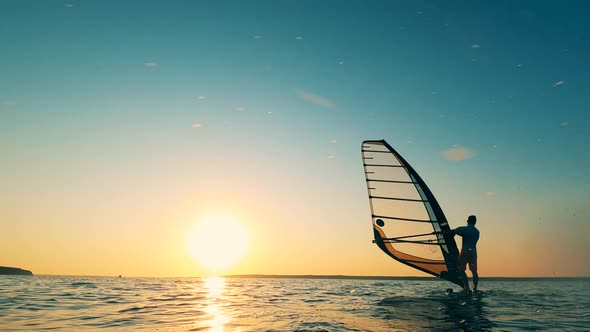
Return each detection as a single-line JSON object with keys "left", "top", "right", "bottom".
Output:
{"left": 451, "top": 216, "right": 479, "bottom": 294}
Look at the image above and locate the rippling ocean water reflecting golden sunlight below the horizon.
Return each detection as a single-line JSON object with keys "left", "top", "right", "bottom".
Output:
{"left": 0, "top": 276, "right": 590, "bottom": 332}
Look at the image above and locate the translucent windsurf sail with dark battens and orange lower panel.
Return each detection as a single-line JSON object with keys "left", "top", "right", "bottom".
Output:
{"left": 361, "top": 140, "right": 463, "bottom": 286}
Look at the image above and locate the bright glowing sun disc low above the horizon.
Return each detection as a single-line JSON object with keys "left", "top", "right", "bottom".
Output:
{"left": 187, "top": 216, "right": 250, "bottom": 273}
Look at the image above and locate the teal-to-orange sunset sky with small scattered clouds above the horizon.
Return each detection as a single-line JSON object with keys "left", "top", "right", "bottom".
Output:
{"left": 0, "top": 0, "right": 590, "bottom": 277}
